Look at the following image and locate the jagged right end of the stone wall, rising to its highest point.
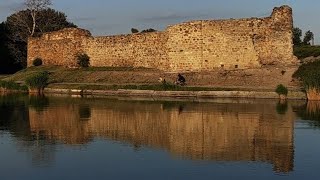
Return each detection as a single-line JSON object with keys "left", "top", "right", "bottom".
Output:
{"left": 252, "top": 6, "right": 297, "bottom": 65}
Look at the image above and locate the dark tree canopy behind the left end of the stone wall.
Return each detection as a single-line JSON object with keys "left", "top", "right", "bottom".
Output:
{"left": 3, "top": 8, "right": 77, "bottom": 72}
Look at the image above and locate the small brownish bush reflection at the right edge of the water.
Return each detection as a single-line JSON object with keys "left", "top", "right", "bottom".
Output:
{"left": 294, "top": 101, "right": 320, "bottom": 128}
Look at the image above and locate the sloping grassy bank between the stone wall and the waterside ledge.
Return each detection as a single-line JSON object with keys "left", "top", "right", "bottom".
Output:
{"left": 4, "top": 66, "right": 297, "bottom": 92}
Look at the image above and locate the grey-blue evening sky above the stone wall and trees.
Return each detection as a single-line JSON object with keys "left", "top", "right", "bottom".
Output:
{"left": 0, "top": 0, "right": 320, "bottom": 44}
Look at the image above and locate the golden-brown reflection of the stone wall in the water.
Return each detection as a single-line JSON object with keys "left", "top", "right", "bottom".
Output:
{"left": 29, "top": 101, "right": 294, "bottom": 172}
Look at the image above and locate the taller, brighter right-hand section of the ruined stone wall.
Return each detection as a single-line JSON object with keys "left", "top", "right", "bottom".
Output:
{"left": 167, "top": 6, "right": 296, "bottom": 71}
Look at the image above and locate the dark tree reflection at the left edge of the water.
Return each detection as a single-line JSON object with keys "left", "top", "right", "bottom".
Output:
{"left": 0, "top": 94, "right": 55, "bottom": 166}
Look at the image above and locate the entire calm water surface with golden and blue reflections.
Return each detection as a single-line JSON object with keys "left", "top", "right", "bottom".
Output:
{"left": 0, "top": 95, "right": 320, "bottom": 180}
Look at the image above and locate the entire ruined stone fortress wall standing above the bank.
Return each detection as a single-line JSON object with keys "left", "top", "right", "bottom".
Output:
{"left": 28, "top": 6, "right": 296, "bottom": 72}
